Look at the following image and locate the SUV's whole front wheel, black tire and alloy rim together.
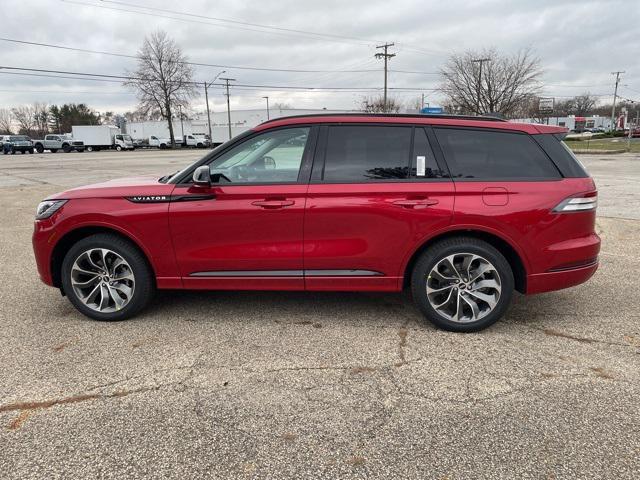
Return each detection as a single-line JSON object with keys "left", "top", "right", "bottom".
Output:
{"left": 61, "top": 233, "right": 155, "bottom": 321}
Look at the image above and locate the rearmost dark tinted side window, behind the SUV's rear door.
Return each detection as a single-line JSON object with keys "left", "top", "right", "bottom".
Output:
{"left": 434, "top": 128, "right": 560, "bottom": 180}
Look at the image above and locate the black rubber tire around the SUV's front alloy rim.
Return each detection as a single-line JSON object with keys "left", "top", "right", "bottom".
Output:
{"left": 61, "top": 233, "right": 155, "bottom": 322}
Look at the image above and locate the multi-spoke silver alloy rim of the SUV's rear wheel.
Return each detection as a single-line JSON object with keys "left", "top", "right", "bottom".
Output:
{"left": 426, "top": 253, "right": 502, "bottom": 323}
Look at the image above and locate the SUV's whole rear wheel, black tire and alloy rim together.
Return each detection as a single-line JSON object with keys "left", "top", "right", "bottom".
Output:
{"left": 411, "top": 237, "right": 514, "bottom": 332}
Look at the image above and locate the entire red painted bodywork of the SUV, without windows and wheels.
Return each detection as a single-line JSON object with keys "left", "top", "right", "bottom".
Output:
{"left": 33, "top": 115, "right": 600, "bottom": 300}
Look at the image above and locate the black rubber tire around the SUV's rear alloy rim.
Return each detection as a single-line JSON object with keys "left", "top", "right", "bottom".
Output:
{"left": 411, "top": 236, "right": 514, "bottom": 332}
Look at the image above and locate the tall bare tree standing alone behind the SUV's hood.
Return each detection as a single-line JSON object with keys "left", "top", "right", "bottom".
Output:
{"left": 125, "top": 30, "right": 196, "bottom": 145}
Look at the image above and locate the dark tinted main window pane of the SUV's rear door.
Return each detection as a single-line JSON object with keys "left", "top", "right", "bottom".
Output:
{"left": 323, "top": 125, "right": 412, "bottom": 183}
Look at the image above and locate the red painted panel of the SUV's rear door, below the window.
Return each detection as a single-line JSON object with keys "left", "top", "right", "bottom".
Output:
{"left": 304, "top": 181, "right": 454, "bottom": 290}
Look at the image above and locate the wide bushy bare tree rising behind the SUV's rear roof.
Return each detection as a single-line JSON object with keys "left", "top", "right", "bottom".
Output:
{"left": 440, "top": 49, "right": 542, "bottom": 116}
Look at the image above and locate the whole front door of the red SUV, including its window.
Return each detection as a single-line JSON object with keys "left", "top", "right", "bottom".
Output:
{"left": 169, "top": 126, "right": 316, "bottom": 289}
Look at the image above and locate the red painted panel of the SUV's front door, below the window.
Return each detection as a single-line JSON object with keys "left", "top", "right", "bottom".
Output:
{"left": 169, "top": 185, "right": 307, "bottom": 289}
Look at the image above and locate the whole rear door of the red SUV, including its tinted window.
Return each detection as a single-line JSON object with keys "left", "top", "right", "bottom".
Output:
{"left": 304, "top": 124, "right": 454, "bottom": 291}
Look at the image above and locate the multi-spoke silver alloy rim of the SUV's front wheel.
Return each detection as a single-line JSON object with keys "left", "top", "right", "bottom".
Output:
{"left": 71, "top": 248, "right": 135, "bottom": 313}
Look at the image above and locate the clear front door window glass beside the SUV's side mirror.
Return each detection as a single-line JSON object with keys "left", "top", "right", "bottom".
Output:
{"left": 209, "top": 127, "right": 309, "bottom": 183}
